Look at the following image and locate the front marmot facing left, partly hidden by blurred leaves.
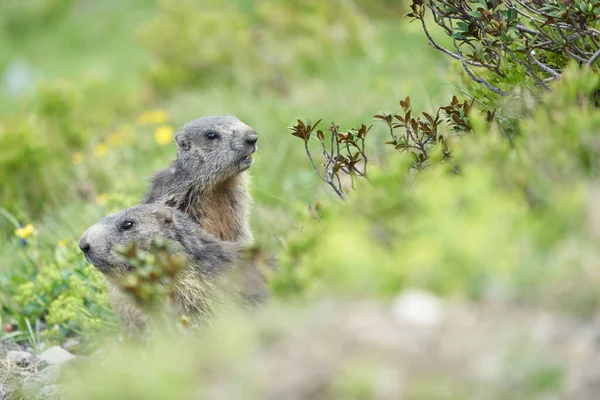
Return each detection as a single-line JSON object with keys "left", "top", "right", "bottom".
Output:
{"left": 79, "top": 204, "right": 240, "bottom": 336}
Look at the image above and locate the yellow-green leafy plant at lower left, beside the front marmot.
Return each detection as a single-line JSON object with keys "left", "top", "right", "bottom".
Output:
{"left": 3, "top": 241, "right": 115, "bottom": 345}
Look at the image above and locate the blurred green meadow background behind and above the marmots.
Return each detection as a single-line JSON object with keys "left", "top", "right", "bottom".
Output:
{"left": 0, "top": 0, "right": 448, "bottom": 241}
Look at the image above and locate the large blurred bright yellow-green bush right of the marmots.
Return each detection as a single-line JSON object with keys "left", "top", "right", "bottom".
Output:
{"left": 273, "top": 67, "right": 600, "bottom": 312}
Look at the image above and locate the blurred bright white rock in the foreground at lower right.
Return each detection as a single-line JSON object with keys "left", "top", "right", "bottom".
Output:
{"left": 392, "top": 290, "right": 444, "bottom": 328}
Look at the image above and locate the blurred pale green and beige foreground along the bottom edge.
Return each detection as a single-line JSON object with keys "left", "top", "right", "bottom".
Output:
{"left": 63, "top": 302, "right": 564, "bottom": 400}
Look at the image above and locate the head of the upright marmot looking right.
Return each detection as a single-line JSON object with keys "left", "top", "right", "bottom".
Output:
{"left": 175, "top": 116, "right": 258, "bottom": 183}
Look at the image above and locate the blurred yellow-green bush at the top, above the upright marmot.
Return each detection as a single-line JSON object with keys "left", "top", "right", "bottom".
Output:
{"left": 140, "top": 0, "right": 368, "bottom": 91}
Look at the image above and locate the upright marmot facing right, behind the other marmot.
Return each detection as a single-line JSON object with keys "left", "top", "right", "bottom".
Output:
{"left": 142, "top": 116, "right": 258, "bottom": 243}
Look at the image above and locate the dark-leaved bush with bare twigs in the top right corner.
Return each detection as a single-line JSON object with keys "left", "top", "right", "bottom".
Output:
{"left": 408, "top": 0, "right": 600, "bottom": 96}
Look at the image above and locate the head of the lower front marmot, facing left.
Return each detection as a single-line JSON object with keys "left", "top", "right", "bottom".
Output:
{"left": 79, "top": 204, "right": 177, "bottom": 277}
